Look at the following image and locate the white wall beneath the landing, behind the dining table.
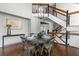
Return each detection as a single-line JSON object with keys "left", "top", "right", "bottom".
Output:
{"left": 31, "top": 16, "right": 53, "bottom": 33}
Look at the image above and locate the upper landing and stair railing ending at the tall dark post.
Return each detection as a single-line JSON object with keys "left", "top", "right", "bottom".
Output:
{"left": 32, "top": 3, "right": 66, "bottom": 16}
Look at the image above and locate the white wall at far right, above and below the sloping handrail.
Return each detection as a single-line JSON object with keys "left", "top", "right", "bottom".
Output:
{"left": 56, "top": 3, "right": 79, "bottom": 26}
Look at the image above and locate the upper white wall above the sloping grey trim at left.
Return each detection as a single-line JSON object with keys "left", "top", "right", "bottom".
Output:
{"left": 0, "top": 3, "right": 32, "bottom": 18}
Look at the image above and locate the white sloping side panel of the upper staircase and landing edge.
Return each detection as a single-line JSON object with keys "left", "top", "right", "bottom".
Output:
{"left": 32, "top": 13, "right": 66, "bottom": 28}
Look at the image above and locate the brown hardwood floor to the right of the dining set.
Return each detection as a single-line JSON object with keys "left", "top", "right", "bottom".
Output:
{"left": 54, "top": 44, "right": 79, "bottom": 56}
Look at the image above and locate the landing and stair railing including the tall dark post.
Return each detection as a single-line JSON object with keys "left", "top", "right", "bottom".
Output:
{"left": 32, "top": 3, "right": 70, "bottom": 46}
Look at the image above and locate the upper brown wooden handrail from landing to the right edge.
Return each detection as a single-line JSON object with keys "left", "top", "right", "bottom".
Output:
{"left": 32, "top": 3, "right": 79, "bottom": 16}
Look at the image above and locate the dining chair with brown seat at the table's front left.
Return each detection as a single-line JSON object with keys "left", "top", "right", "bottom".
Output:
{"left": 21, "top": 37, "right": 35, "bottom": 56}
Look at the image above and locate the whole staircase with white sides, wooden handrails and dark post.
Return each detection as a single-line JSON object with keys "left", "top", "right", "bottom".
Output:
{"left": 32, "top": 4, "right": 79, "bottom": 45}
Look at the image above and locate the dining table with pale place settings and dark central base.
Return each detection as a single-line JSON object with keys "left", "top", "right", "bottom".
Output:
{"left": 20, "top": 35, "right": 54, "bottom": 55}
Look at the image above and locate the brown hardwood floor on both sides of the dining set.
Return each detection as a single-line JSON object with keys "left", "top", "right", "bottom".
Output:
{"left": 0, "top": 43, "right": 79, "bottom": 56}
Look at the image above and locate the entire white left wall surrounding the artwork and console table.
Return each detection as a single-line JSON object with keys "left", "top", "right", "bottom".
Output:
{"left": 0, "top": 3, "right": 32, "bottom": 47}
